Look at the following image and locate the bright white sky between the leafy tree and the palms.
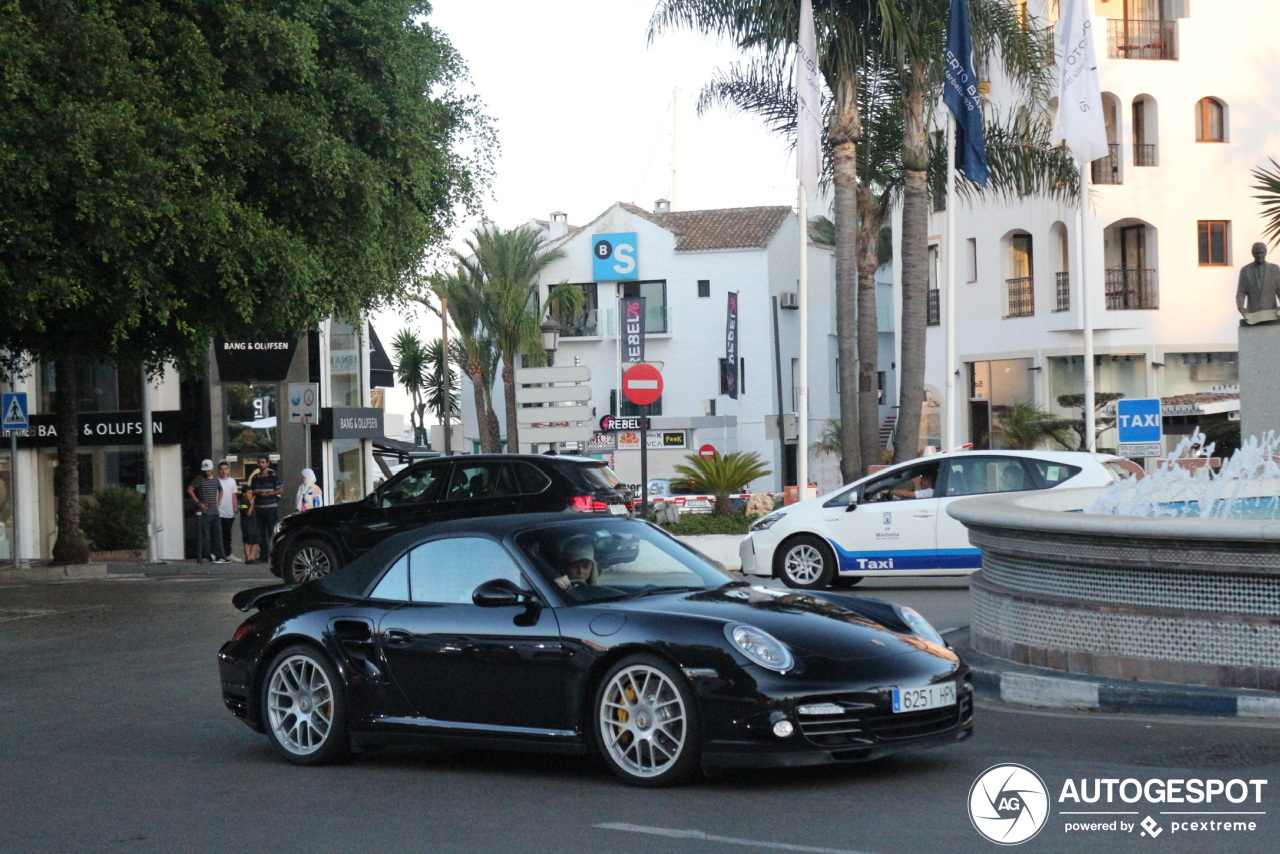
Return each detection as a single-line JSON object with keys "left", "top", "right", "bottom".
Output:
{"left": 374, "top": 0, "right": 796, "bottom": 427}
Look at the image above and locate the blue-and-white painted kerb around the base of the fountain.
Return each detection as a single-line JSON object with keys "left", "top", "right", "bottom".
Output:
{"left": 946, "top": 626, "right": 1280, "bottom": 722}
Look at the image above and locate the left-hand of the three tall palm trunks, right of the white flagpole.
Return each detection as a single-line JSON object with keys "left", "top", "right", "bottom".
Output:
{"left": 829, "top": 73, "right": 863, "bottom": 489}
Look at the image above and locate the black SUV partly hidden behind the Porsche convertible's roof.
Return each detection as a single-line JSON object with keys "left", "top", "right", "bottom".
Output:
{"left": 271, "top": 453, "right": 631, "bottom": 584}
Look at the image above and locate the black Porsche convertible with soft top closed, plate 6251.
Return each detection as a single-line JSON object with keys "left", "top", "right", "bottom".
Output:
{"left": 219, "top": 513, "right": 973, "bottom": 786}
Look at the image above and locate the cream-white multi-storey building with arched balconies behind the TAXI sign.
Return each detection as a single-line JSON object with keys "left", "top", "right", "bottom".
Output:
{"left": 922, "top": 0, "right": 1280, "bottom": 448}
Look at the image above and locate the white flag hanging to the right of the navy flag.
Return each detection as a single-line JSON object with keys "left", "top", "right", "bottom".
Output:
{"left": 1053, "top": 0, "right": 1108, "bottom": 163}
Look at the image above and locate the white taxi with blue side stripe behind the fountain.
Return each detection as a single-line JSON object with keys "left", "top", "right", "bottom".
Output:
{"left": 739, "top": 451, "right": 1140, "bottom": 589}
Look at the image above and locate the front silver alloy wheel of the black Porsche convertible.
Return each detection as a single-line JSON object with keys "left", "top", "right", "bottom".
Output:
{"left": 599, "top": 665, "right": 689, "bottom": 777}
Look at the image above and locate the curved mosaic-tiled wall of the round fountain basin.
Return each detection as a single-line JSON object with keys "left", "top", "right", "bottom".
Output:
{"left": 948, "top": 489, "right": 1280, "bottom": 691}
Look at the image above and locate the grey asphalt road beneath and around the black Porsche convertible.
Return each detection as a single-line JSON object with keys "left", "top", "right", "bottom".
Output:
{"left": 0, "top": 567, "right": 1280, "bottom": 854}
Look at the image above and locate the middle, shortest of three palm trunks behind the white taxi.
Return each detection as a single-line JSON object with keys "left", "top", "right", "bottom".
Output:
{"left": 858, "top": 186, "right": 882, "bottom": 466}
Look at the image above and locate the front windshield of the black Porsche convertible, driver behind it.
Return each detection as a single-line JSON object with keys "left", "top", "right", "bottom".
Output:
{"left": 516, "top": 520, "right": 733, "bottom": 604}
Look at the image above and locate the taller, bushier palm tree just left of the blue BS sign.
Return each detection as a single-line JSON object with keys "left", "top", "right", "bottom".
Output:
{"left": 451, "top": 224, "right": 565, "bottom": 451}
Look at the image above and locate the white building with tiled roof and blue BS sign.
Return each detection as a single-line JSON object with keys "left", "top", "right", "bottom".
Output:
{"left": 462, "top": 202, "right": 860, "bottom": 490}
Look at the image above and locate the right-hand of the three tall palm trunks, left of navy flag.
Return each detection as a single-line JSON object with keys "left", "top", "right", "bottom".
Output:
{"left": 893, "top": 81, "right": 929, "bottom": 462}
